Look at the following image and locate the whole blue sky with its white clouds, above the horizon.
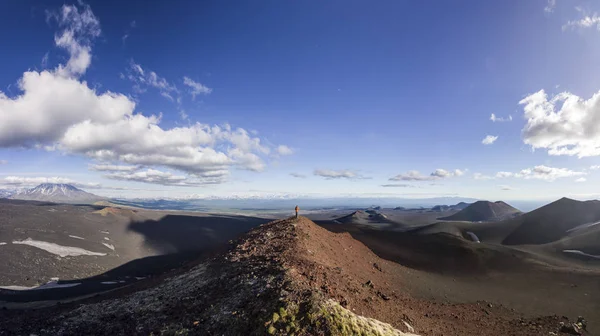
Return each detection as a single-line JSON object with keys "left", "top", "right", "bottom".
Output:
{"left": 0, "top": 0, "right": 600, "bottom": 200}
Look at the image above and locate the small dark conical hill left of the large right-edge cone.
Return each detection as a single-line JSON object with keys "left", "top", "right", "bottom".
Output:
{"left": 440, "top": 201, "right": 521, "bottom": 222}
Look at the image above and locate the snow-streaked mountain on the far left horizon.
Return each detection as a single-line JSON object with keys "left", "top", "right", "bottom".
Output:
{"left": 9, "top": 183, "right": 106, "bottom": 204}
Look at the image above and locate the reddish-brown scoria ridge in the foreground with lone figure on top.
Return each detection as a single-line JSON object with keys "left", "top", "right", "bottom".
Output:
{"left": 0, "top": 217, "right": 572, "bottom": 335}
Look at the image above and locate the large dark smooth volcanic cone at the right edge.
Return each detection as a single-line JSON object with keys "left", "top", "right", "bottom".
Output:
{"left": 502, "top": 198, "right": 600, "bottom": 245}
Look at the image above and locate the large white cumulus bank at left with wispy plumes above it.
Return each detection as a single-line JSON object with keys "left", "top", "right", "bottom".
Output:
{"left": 0, "top": 5, "right": 288, "bottom": 186}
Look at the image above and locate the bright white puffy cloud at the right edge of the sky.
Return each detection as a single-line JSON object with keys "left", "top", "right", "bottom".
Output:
{"left": 519, "top": 90, "right": 600, "bottom": 158}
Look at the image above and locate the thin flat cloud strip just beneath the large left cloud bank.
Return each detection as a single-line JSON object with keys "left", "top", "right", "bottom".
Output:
{"left": 104, "top": 169, "right": 223, "bottom": 187}
